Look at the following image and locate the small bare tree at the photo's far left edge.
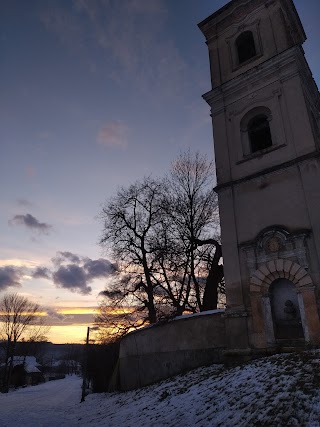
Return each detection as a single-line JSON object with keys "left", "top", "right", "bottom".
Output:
{"left": 0, "top": 293, "right": 45, "bottom": 391}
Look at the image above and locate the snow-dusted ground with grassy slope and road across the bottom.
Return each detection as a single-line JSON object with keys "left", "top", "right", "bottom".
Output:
{"left": 0, "top": 352, "right": 320, "bottom": 427}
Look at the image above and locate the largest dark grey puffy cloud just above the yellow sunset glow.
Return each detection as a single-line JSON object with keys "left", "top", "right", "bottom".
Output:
{"left": 52, "top": 264, "right": 92, "bottom": 295}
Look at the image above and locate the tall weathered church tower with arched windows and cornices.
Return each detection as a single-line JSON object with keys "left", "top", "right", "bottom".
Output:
{"left": 199, "top": 0, "right": 320, "bottom": 350}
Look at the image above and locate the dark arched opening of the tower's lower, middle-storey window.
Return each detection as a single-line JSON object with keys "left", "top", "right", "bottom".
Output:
{"left": 248, "top": 114, "right": 272, "bottom": 153}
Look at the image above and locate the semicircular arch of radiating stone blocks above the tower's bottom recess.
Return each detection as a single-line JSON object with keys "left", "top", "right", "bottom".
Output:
{"left": 250, "top": 259, "right": 313, "bottom": 294}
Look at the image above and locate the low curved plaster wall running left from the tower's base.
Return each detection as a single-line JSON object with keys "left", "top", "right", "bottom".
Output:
{"left": 119, "top": 311, "right": 225, "bottom": 390}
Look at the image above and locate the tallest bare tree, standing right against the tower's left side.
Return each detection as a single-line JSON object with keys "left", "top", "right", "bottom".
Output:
{"left": 167, "top": 151, "right": 223, "bottom": 311}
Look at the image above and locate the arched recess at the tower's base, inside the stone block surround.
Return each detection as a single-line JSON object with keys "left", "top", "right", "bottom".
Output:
{"left": 269, "top": 279, "right": 304, "bottom": 340}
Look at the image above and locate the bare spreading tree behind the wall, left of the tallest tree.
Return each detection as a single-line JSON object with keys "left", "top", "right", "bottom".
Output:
{"left": 100, "top": 178, "right": 164, "bottom": 323}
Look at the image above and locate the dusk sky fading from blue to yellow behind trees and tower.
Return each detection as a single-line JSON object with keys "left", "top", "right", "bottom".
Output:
{"left": 0, "top": 0, "right": 320, "bottom": 343}
